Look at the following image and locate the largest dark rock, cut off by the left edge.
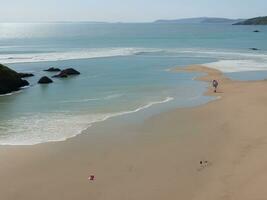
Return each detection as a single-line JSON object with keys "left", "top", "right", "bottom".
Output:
{"left": 0, "top": 64, "right": 29, "bottom": 94}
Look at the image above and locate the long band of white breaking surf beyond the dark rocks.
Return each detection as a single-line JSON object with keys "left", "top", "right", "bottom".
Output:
{"left": 3, "top": 47, "right": 267, "bottom": 72}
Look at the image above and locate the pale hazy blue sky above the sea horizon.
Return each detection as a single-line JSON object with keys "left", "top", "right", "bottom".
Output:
{"left": 0, "top": 0, "right": 267, "bottom": 22}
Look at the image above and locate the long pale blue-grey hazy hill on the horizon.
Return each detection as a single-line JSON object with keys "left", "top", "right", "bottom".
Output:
{"left": 155, "top": 17, "right": 244, "bottom": 24}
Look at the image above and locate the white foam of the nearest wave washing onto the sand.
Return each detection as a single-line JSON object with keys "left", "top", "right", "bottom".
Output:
{"left": 0, "top": 97, "right": 173, "bottom": 145}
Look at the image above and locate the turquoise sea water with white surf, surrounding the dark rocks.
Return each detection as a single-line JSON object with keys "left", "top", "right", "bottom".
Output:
{"left": 0, "top": 23, "right": 267, "bottom": 145}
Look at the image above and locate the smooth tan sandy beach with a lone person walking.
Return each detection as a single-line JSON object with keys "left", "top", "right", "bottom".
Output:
{"left": 0, "top": 65, "right": 267, "bottom": 200}
